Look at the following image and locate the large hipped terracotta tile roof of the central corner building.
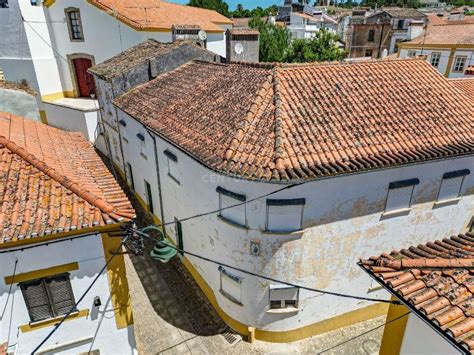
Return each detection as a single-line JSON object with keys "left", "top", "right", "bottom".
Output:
{"left": 114, "top": 59, "right": 474, "bottom": 180}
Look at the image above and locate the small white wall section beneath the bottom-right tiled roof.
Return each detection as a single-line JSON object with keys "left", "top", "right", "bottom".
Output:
{"left": 400, "top": 313, "right": 462, "bottom": 355}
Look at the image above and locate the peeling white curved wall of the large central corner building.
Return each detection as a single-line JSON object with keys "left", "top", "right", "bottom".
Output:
{"left": 115, "top": 108, "right": 474, "bottom": 331}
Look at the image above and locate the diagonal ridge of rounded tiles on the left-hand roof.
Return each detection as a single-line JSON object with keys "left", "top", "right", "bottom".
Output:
{"left": 0, "top": 135, "right": 119, "bottom": 215}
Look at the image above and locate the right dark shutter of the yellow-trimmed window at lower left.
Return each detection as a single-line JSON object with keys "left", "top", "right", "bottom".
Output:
{"left": 45, "top": 274, "right": 76, "bottom": 317}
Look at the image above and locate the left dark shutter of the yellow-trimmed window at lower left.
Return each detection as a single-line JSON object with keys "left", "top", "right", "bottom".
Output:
{"left": 20, "top": 280, "right": 53, "bottom": 322}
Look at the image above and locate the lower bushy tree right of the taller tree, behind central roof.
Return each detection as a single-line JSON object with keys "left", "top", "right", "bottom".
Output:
{"left": 285, "top": 29, "right": 345, "bottom": 63}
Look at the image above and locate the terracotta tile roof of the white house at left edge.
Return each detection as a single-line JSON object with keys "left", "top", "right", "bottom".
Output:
{"left": 0, "top": 112, "right": 135, "bottom": 244}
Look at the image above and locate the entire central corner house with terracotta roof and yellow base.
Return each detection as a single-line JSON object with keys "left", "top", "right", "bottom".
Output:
{"left": 94, "top": 59, "right": 474, "bottom": 342}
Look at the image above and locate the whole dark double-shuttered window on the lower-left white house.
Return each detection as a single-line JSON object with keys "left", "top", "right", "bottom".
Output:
{"left": 20, "top": 274, "right": 76, "bottom": 322}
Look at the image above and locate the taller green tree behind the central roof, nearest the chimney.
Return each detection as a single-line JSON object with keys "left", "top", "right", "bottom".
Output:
{"left": 249, "top": 17, "right": 290, "bottom": 62}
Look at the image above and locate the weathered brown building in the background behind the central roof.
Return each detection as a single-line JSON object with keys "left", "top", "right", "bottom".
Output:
{"left": 342, "top": 7, "right": 426, "bottom": 58}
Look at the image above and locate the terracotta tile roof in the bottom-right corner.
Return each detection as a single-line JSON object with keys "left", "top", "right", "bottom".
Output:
{"left": 361, "top": 233, "right": 474, "bottom": 352}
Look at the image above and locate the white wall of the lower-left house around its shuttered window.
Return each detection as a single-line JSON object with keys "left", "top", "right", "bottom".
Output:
{"left": 0, "top": 235, "right": 136, "bottom": 354}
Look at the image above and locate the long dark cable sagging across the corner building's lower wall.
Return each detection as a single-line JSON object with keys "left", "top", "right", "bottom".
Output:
{"left": 134, "top": 230, "right": 401, "bottom": 304}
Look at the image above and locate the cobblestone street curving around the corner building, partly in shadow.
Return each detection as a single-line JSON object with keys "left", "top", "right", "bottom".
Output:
{"left": 111, "top": 163, "right": 385, "bottom": 355}
